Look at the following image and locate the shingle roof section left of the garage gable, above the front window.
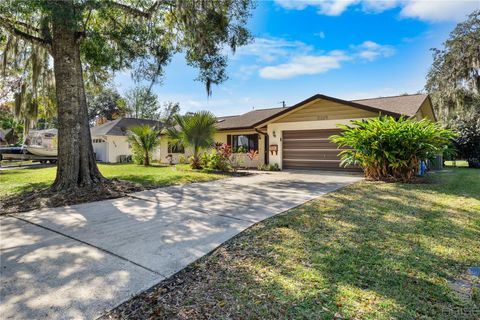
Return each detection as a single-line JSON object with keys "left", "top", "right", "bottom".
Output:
{"left": 217, "top": 108, "right": 286, "bottom": 130}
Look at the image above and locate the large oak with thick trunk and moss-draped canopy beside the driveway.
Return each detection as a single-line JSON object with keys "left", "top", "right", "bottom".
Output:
{"left": 0, "top": 0, "right": 252, "bottom": 191}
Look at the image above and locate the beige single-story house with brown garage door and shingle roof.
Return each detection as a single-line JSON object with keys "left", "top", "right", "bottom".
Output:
{"left": 160, "top": 94, "right": 436, "bottom": 170}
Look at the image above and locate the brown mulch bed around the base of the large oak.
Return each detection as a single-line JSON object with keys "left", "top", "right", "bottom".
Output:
{"left": 0, "top": 179, "right": 145, "bottom": 215}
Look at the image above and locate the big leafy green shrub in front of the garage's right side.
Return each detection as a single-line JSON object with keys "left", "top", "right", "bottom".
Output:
{"left": 330, "top": 117, "right": 455, "bottom": 182}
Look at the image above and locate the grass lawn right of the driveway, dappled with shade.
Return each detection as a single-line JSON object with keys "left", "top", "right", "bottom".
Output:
{"left": 110, "top": 169, "right": 480, "bottom": 319}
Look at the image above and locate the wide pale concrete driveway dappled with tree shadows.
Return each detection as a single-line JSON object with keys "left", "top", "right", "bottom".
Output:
{"left": 0, "top": 171, "right": 361, "bottom": 319}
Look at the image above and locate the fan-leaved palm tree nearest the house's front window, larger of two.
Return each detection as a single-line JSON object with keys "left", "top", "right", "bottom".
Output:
{"left": 167, "top": 111, "right": 217, "bottom": 169}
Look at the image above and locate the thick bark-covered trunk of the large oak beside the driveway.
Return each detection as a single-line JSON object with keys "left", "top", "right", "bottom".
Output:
{"left": 52, "top": 17, "right": 106, "bottom": 191}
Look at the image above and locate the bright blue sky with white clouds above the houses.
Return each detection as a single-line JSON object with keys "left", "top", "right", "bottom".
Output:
{"left": 115, "top": 0, "right": 480, "bottom": 115}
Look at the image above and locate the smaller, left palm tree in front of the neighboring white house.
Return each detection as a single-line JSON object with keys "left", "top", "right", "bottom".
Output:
{"left": 127, "top": 124, "right": 160, "bottom": 166}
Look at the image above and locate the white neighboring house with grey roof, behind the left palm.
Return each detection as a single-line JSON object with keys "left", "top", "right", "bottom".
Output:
{"left": 90, "top": 118, "right": 162, "bottom": 163}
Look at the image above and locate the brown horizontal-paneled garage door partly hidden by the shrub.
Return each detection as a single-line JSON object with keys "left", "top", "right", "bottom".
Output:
{"left": 282, "top": 129, "right": 358, "bottom": 170}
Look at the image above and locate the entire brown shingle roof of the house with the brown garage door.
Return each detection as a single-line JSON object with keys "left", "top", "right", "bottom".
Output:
{"left": 217, "top": 94, "right": 428, "bottom": 130}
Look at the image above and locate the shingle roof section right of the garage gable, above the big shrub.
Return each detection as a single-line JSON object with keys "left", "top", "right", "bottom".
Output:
{"left": 352, "top": 93, "right": 428, "bottom": 117}
